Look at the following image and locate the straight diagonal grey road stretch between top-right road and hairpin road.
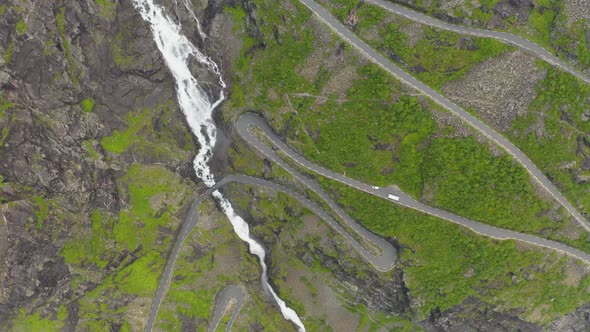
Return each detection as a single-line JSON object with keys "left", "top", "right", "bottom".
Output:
{"left": 299, "top": 0, "right": 590, "bottom": 232}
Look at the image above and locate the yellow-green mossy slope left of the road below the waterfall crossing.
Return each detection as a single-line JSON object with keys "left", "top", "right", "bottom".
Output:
{"left": 67, "top": 163, "right": 192, "bottom": 330}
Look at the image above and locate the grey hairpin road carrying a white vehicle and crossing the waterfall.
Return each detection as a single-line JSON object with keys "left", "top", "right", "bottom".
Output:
{"left": 145, "top": 113, "right": 590, "bottom": 332}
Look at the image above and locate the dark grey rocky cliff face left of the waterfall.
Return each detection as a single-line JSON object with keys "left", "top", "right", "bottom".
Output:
{"left": 0, "top": 0, "right": 193, "bottom": 329}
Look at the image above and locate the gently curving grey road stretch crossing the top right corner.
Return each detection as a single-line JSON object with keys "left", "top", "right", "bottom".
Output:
{"left": 365, "top": 0, "right": 590, "bottom": 83}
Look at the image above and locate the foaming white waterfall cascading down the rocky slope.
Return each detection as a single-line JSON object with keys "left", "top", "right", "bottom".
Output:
{"left": 133, "top": 0, "right": 305, "bottom": 331}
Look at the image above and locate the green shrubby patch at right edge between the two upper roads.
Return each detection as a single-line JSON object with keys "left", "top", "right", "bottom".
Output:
{"left": 511, "top": 68, "right": 590, "bottom": 211}
